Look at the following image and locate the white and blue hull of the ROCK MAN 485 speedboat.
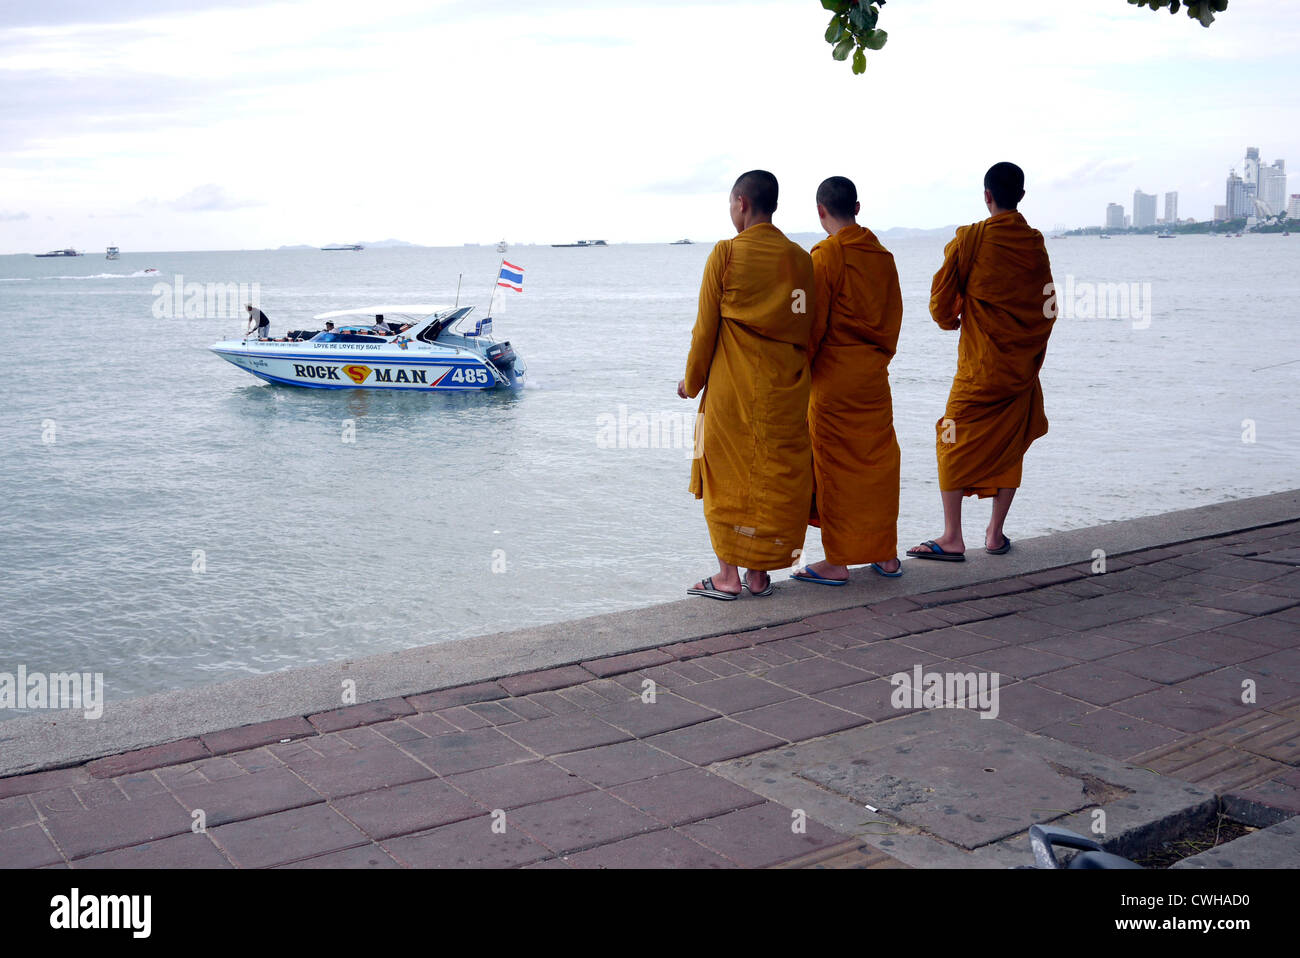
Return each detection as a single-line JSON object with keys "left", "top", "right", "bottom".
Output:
{"left": 211, "top": 342, "right": 524, "bottom": 393}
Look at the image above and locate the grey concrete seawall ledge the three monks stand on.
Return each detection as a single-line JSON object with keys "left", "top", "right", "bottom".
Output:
{"left": 0, "top": 490, "right": 1300, "bottom": 776}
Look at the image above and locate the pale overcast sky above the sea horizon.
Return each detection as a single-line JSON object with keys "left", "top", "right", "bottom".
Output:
{"left": 0, "top": 0, "right": 1300, "bottom": 252}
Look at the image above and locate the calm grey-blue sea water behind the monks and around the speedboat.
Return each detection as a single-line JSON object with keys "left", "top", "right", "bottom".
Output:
{"left": 0, "top": 235, "right": 1300, "bottom": 719}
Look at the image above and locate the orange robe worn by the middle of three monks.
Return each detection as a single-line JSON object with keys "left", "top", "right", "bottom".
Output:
{"left": 809, "top": 226, "right": 902, "bottom": 565}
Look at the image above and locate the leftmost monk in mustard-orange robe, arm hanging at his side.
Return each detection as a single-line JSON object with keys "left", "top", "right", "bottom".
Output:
{"left": 677, "top": 170, "right": 813, "bottom": 599}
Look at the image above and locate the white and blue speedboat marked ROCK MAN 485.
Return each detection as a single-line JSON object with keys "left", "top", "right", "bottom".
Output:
{"left": 209, "top": 305, "right": 527, "bottom": 393}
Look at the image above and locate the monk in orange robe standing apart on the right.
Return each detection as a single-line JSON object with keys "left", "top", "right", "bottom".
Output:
{"left": 907, "top": 162, "right": 1056, "bottom": 562}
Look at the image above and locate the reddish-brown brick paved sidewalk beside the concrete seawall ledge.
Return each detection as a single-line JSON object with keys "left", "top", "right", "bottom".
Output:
{"left": 0, "top": 523, "right": 1300, "bottom": 868}
